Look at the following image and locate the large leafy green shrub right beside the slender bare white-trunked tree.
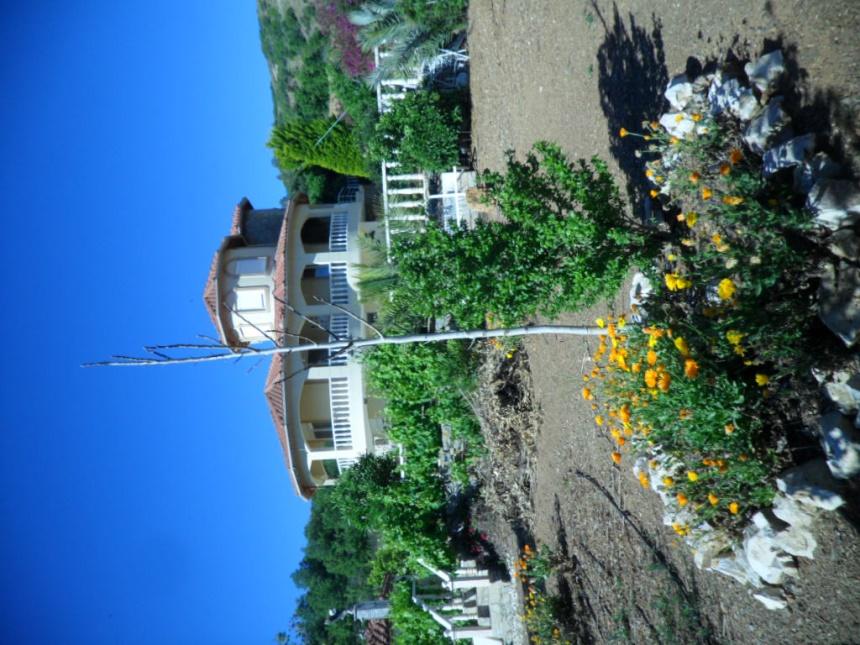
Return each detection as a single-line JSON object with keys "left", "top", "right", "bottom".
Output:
{"left": 392, "top": 143, "right": 654, "bottom": 328}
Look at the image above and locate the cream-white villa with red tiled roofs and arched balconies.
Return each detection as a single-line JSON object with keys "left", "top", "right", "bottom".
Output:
{"left": 203, "top": 187, "right": 389, "bottom": 499}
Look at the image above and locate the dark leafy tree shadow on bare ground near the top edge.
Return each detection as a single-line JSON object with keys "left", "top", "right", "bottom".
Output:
{"left": 592, "top": 3, "right": 669, "bottom": 214}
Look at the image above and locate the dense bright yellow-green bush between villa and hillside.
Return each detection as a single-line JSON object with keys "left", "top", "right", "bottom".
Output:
{"left": 269, "top": 119, "right": 367, "bottom": 177}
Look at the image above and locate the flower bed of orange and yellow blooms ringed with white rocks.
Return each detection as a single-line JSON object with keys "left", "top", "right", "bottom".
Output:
{"left": 582, "top": 52, "right": 860, "bottom": 609}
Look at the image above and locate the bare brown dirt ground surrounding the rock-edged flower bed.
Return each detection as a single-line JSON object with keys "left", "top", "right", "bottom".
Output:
{"left": 469, "top": 0, "right": 860, "bottom": 643}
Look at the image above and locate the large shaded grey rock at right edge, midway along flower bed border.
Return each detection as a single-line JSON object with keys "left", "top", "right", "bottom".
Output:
{"left": 818, "top": 264, "right": 860, "bottom": 347}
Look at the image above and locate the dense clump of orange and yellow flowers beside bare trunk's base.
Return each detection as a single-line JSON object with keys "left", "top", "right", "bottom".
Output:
{"left": 587, "top": 318, "right": 779, "bottom": 534}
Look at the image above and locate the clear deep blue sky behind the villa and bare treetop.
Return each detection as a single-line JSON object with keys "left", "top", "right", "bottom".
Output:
{"left": 0, "top": 0, "right": 309, "bottom": 645}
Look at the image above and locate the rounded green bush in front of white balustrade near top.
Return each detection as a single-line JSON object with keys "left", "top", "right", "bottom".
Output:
{"left": 369, "top": 90, "right": 463, "bottom": 172}
